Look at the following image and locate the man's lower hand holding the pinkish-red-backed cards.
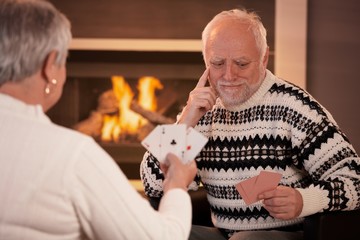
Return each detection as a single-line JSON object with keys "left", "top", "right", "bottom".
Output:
{"left": 259, "top": 186, "right": 303, "bottom": 219}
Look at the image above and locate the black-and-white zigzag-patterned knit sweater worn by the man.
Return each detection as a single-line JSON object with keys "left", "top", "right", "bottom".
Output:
{"left": 140, "top": 71, "right": 360, "bottom": 231}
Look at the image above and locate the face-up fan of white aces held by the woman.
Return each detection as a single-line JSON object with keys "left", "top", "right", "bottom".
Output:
{"left": 141, "top": 124, "right": 208, "bottom": 163}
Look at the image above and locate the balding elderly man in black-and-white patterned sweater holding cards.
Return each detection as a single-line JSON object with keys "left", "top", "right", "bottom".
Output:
{"left": 141, "top": 9, "right": 360, "bottom": 239}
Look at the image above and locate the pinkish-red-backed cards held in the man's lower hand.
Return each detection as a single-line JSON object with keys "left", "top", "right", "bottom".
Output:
{"left": 235, "top": 171, "right": 282, "bottom": 205}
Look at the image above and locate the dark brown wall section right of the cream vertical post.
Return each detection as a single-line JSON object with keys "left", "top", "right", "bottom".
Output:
{"left": 307, "top": 0, "right": 360, "bottom": 152}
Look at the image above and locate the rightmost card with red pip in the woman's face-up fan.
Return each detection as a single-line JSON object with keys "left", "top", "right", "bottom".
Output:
{"left": 183, "top": 127, "right": 208, "bottom": 162}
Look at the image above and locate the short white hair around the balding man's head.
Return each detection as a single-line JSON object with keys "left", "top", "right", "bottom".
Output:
{"left": 202, "top": 9, "right": 268, "bottom": 57}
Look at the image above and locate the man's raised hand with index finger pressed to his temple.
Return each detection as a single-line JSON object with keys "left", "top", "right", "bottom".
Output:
{"left": 178, "top": 69, "right": 216, "bottom": 127}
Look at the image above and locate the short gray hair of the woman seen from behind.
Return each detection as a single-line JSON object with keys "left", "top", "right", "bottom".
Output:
{"left": 0, "top": 0, "right": 72, "bottom": 85}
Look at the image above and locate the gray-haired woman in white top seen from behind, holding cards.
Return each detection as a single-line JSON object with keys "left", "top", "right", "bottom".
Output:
{"left": 0, "top": 0, "right": 196, "bottom": 240}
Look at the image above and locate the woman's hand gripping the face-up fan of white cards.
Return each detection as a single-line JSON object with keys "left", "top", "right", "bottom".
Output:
{"left": 160, "top": 153, "right": 197, "bottom": 192}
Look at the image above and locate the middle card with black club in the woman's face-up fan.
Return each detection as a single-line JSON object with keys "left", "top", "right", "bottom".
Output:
{"left": 158, "top": 124, "right": 186, "bottom": 162}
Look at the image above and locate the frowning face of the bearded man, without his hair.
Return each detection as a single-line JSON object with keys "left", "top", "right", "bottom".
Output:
{"left": 205, "top": 20, "right": 267, "bottom": 106}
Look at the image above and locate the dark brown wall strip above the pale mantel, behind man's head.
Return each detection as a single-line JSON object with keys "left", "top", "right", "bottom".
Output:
{"left": 50, "top": 0, "right": 275, "bottom": 45}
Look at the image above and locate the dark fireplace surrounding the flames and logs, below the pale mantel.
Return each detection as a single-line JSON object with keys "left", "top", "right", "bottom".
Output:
{"left": 48, "top": 47, "right": 204, "bottom": 179}
